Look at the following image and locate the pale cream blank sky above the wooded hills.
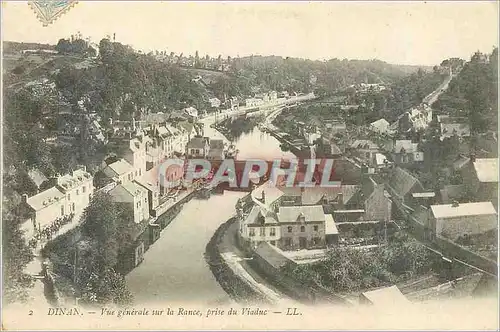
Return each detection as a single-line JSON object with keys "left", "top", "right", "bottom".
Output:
{"left": 2, "top": 1, "right": 498, "bottom": 65}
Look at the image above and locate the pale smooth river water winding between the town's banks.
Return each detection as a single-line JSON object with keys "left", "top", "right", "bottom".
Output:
{"left": 126, "top": 116, "right": 293, "bottom": 305}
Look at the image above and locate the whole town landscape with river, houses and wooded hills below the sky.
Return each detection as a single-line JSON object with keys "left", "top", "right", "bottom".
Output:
{"left": 2, "top": 9, "right": 498, "bottom": 328}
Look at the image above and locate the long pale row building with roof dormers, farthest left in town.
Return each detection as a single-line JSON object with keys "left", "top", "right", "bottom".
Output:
{"left": 20, "top": 167, "right": 94, "bottom": 237}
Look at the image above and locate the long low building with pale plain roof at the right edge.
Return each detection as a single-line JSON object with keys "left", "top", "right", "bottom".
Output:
{"left": 426, "top": 202, "right": 498, "bottom": 241}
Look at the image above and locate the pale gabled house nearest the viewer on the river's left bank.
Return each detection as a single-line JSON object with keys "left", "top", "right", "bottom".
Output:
{"left": 109, "top": 181, "right": 149, "bottom": 224}
